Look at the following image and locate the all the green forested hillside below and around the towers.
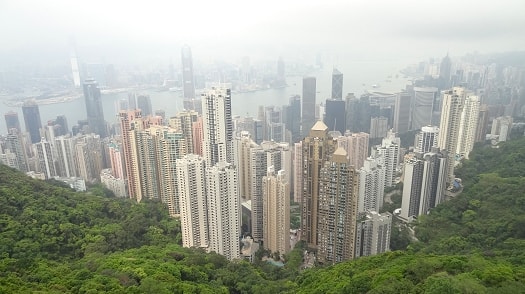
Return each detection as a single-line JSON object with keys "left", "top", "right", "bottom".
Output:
{"left": 0, "top": 139, "right": 525, "bottom": 293}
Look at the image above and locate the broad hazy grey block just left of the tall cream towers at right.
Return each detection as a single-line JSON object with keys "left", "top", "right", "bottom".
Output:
{"left": 411, "top": 87, "right": 437, "bottom": 130}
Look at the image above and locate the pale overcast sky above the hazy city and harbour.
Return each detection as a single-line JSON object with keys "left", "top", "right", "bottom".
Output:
{"left": 0, "top": 0, "right": 525, "bottom": 63}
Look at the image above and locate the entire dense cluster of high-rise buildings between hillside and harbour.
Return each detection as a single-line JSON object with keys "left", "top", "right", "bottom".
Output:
{"left": 0, "top": 47, "right": 512, "bottom": 264}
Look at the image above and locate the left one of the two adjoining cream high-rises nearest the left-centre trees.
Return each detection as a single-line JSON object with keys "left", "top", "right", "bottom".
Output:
{"left": 176, "top": 154, "right": 209, "bottom": 248}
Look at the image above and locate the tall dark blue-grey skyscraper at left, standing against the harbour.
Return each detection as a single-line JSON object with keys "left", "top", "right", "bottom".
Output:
{"left": 84, "top": 79, "right": 107, "bottom": 138}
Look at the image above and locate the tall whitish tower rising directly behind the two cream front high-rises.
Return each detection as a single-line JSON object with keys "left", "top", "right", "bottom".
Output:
{"left": 202, "top": 88, "right": 233, "bottom": 167}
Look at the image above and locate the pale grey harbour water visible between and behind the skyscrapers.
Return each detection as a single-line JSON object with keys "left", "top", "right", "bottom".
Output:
{"left": 0, "top": 62, "right": 410, "bottom": 134}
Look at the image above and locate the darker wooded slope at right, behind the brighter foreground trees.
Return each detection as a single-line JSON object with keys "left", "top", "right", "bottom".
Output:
{"left": 415, "top": 139, "right": 525, "bottom": 265}
